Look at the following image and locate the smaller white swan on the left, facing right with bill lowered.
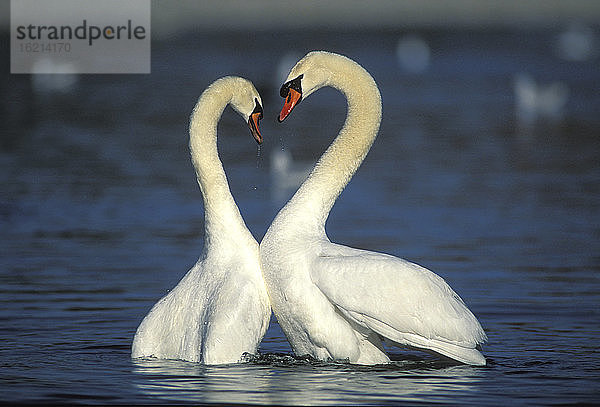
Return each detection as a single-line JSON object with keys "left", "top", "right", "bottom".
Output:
{"left": 131, "top": 77, "right": 271, "bottom": 364}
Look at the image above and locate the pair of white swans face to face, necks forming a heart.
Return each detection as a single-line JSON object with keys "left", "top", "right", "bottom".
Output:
{"left": 132, "top": 51, "right": 487, "bottom": 365}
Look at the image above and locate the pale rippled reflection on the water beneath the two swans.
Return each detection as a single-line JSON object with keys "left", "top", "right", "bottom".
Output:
{"left": 133, "top": 354, "right": 485, "bottom": 405}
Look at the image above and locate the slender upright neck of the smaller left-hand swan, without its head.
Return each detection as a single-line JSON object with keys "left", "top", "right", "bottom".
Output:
{"left": 190, "top": 78, "right": 250, "bottom": 247}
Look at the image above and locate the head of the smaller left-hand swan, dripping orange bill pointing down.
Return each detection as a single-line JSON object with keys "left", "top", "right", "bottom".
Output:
{"left": 230, "top": 78, "right": 263, "bottom": 144}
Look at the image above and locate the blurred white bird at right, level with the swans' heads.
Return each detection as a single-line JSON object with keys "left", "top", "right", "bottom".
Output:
{"left": 513, "top": 73, "right": 569, "bottom": 130}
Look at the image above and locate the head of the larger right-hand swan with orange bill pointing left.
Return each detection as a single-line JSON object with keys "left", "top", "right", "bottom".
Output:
{"left": 278, "top": 51, "right": 348, "bottom": 123}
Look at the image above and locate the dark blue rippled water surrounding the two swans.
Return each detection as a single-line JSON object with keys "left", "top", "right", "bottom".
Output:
{"left": 0, "top": 27, "right": 600, "bottom": 406}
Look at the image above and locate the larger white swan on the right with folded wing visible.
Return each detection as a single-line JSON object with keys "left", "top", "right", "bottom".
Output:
{"left": 260, "top": 52, "right": 487, "bottom": 365}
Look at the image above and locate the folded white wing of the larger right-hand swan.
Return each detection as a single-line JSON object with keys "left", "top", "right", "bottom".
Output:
{"left": 310, "top": 243, "right": 487, "bottom": 365}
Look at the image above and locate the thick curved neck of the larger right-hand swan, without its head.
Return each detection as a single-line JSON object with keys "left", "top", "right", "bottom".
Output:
{"left": 284, "top": 59, "right": 381, "bottom": 233}
